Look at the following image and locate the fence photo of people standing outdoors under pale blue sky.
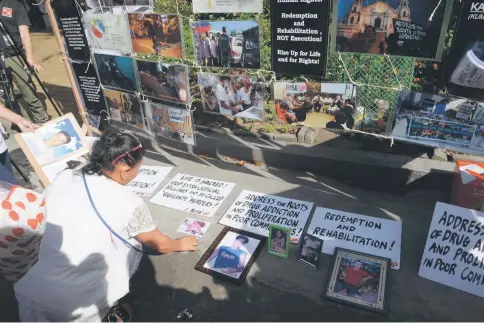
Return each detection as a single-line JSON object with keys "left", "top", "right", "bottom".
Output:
{"left": 192, "top": 20, "right": 260, "bottom": 68}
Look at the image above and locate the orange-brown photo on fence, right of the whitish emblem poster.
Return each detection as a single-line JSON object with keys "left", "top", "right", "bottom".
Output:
{"left": 128, "top": 13, "right": 183, "bottom": 58}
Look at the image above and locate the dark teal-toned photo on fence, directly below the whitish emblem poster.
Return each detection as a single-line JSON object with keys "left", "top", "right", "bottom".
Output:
{"left": 94, "top": 54, "right": 139, "bottom": 93}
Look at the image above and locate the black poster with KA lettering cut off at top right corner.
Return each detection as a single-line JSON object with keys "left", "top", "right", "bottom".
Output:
{"left": 443, "top": 0, "right": 484, "bottom": 97}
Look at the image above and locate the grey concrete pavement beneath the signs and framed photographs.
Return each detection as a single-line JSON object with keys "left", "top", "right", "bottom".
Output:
{"left": 0, "top": 134, "right": 484, "bottom": 321}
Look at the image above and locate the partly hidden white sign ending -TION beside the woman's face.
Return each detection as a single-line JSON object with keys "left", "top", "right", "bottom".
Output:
{"left": 128, "top": 165, "right": 173, "bottom": 196}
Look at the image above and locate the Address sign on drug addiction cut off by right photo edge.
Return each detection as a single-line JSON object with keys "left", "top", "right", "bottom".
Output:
{"left": 418, "top": 202, "right": 484, "bottom": 297}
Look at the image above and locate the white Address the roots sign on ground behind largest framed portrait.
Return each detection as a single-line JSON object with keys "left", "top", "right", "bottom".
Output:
{"left": 219, "top": 190, "right": 314, "bottom": 243}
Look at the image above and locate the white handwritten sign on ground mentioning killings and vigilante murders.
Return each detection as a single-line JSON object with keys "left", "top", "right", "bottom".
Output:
{"left": 150, "top": 174, "right": 235, "bottom": 217}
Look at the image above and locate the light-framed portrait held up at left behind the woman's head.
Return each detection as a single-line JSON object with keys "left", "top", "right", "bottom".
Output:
{"left": 15, "top": 113, "right": 89, "bottom": 186}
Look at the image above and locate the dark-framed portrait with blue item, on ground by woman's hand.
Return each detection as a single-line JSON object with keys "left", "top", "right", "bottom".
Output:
{"left": 195, "top": 227, "right": 267, "bottom": 285}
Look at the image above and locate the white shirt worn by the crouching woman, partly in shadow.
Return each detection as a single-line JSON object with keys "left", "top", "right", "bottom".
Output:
{"left": 14, "top": 170, "right": 156, "bottom": 322}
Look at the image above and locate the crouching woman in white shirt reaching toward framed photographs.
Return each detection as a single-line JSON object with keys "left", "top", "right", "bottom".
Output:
{"left": 15, "top": 129, "right": 198, "bottom": 322}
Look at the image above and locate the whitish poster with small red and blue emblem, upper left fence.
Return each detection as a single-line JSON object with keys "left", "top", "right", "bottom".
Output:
{"left": 84, "top": 10, "right": 131, "bottom": 55}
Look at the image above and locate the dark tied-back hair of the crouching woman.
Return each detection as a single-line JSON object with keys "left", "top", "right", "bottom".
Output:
{"left": 81, "top": 128, "right": 145, "bottom": 175}
